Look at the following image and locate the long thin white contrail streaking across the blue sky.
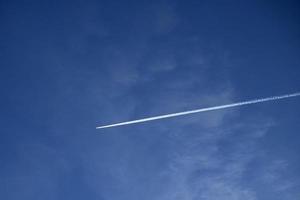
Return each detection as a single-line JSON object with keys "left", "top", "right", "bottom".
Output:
{"left": 96, "top": 92, "right": 300, "bottom": 129}
